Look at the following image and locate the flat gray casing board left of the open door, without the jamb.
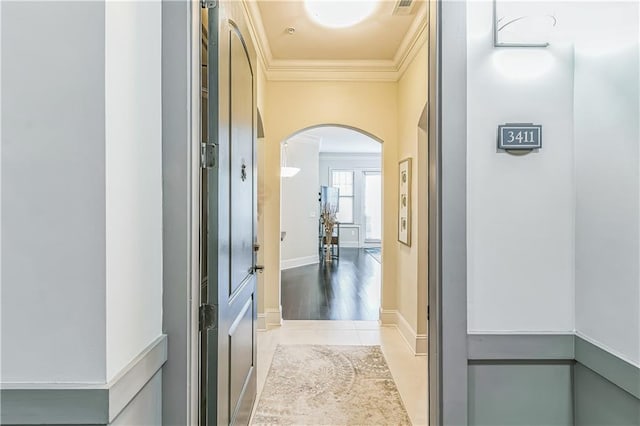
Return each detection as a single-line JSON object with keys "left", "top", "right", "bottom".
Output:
{"left": 162, "top": 0, "right": 198, "bottom": 425}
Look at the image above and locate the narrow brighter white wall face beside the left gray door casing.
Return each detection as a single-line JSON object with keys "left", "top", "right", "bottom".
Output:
{"left": 105, "top": 1, "right": 162, "bottom": 380}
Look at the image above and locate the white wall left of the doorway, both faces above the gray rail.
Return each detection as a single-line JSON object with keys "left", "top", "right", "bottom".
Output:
{"left": 0, "top": 2, "right": 162, "bottom": 390}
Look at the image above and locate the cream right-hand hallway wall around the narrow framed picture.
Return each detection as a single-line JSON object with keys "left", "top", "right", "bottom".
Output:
{"left": 397, "top": 43, "right": 428, "bottom": 340}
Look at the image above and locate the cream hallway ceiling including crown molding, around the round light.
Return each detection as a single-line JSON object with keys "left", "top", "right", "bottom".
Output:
{"left": 245, "top": 0, "right": 427, "bottom": 81}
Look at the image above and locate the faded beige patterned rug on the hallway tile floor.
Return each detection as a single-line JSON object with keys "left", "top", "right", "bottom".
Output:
{"left": 252, "top": 345, "right": 411, "bottom": 426}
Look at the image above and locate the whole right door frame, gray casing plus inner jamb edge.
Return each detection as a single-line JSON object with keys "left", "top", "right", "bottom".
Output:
{"left": 428, "top": 0, "right": 468, "bottom": 426}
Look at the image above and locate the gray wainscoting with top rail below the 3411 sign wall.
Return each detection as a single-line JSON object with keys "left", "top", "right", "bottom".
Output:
{"left": 467, "top": 334, "right": 640, "bottom": 426}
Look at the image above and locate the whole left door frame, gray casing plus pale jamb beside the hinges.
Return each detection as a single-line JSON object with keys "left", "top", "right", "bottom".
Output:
{"left": 161, "top": 1, "right": 200, "bottom": 424}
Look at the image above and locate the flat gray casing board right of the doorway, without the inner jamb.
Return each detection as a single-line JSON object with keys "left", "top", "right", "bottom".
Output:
{"left": 438, "top": 1, "right": 467, "bottom": 425}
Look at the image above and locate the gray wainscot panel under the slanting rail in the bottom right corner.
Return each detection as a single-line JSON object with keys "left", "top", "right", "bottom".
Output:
{"left": 574, "top": 363, "right": 640, "bottom": 426}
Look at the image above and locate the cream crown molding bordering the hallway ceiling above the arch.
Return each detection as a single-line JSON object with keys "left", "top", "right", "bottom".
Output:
{"left": 242, "top": 0, "right": 428, "bottom": 82}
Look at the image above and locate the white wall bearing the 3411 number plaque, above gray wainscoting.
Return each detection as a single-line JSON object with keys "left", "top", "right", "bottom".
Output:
{"left": 468, "top": 1, "right": 640, "bottom": 365}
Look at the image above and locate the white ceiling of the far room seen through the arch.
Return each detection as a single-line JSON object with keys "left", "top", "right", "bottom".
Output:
{"left": 292, "top": 126, "right": 382, "bottom": 154}
